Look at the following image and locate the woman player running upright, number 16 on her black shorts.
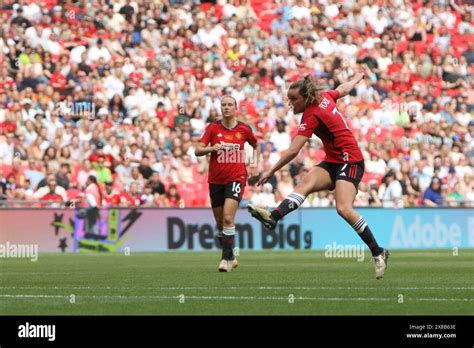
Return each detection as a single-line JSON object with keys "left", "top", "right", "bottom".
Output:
{"left": 195, "top": 95, "right": 260, "bottom": 272}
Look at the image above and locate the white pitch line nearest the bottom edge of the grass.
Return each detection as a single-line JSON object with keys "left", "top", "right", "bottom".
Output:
{"left": 0, "top": 294, "right": 474, "bottom": 302}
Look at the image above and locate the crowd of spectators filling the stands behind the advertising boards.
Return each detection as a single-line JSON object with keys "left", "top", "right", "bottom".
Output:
{"left": 0, "top": 0, "right": 474, "bottom": 208}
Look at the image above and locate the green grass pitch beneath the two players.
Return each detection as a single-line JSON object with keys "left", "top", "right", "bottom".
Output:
{"left": 0, "top": 249, "right": 474, "bottom": 315}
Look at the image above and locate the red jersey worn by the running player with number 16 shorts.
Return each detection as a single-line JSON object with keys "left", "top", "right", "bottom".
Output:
{"left": 200, "top": 121, "right": 257, "bottom": 184}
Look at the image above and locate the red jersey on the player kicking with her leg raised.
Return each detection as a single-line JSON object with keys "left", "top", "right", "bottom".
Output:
{"left": 297, "top": 90, "right": 364, "bottom": 163}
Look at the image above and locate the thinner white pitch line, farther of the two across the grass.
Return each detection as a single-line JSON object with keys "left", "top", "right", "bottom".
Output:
{"left": 0, "top": 286, "right": 474, "bottom": 291}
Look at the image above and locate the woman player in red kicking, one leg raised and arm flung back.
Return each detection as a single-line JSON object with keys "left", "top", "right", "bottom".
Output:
{"left": 248, "top": 73, "right": 389, "bottom": 279}
